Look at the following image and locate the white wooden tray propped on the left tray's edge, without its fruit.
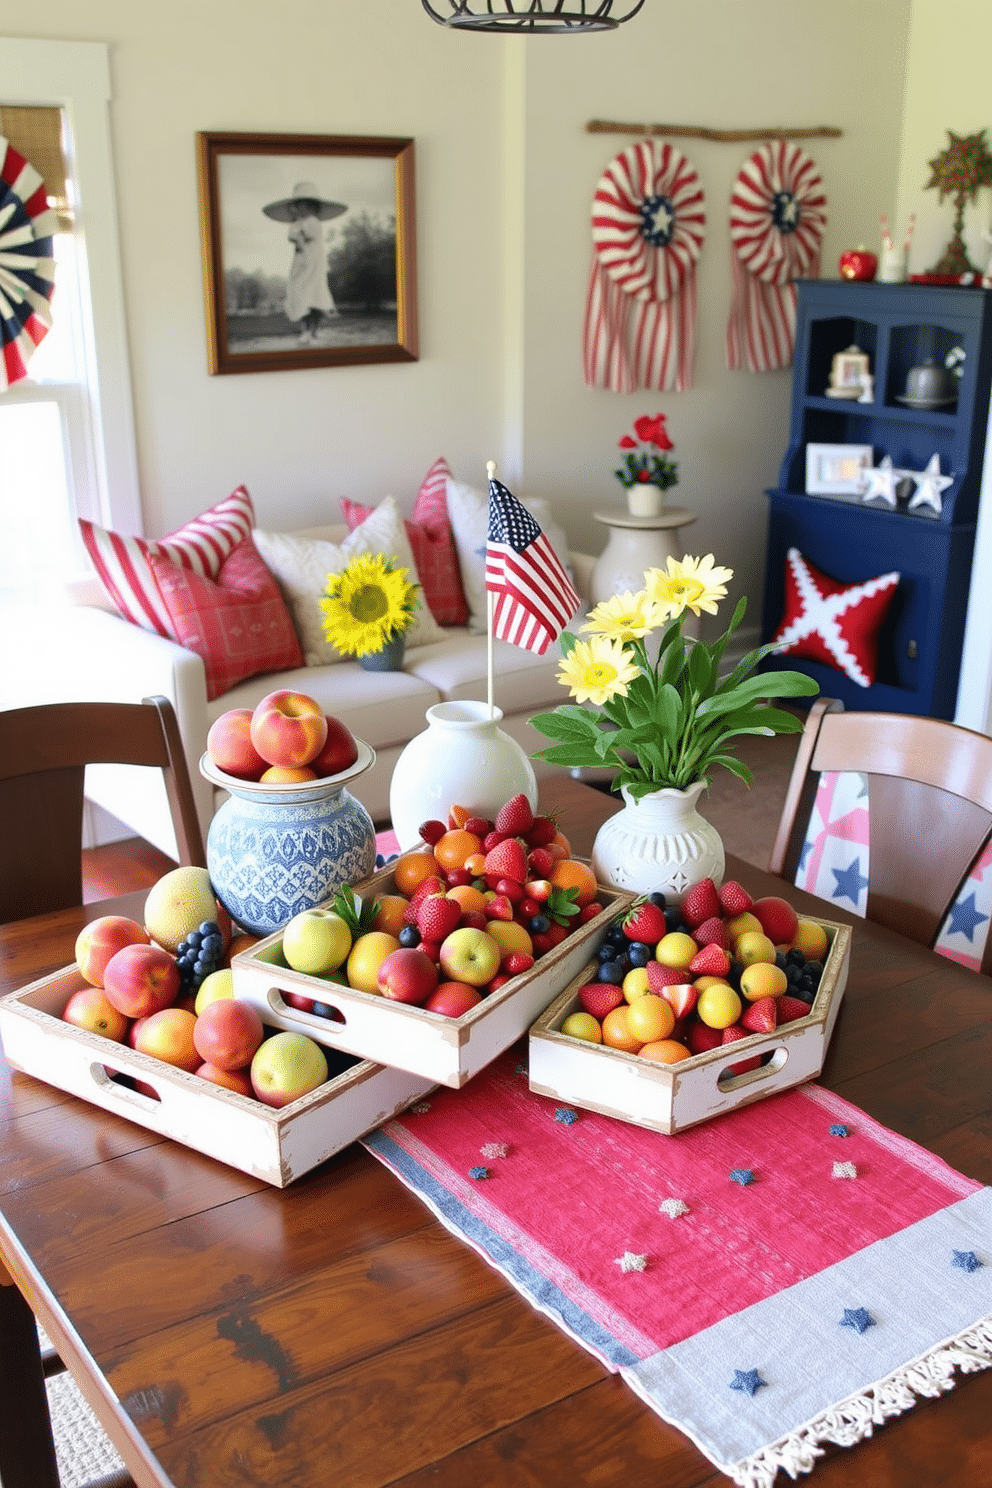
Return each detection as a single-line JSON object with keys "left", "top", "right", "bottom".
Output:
{"left": 231, "top": 868, "right": 634, "bottom": 1088}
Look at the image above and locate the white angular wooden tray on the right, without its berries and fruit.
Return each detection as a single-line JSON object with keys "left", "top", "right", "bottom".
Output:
{"left": 529, "top": 920, "right": 851, "bottom": 1135}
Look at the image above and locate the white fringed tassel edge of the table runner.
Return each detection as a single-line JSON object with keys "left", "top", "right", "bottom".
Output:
{"left": 722, "top": 1317, "right": 992, "bottom": 1488}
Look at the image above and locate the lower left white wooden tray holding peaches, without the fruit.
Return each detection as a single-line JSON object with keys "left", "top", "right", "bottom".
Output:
{"left": 0, "top": 966, "right": 433, "bottom": 1187}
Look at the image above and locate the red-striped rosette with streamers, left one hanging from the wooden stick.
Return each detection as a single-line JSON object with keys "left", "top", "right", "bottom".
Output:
{"left": 583, "top": 140, "right": 706, "bottom": 393}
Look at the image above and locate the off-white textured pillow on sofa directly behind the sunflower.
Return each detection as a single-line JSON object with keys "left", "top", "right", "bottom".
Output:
{"left": 251, "top": 496, "right": 445, "bottom": 667}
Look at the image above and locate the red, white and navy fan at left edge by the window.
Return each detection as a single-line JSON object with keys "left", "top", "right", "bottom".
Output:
{"left": 0, "top": 135, "right": 55, "bottom": 391}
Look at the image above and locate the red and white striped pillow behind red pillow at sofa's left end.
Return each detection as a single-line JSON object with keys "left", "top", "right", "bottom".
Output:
{"left": 79, "top": 485, "right": 254, "bottom": 641}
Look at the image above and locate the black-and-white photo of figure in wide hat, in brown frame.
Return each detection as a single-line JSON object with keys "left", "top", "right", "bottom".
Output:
{"left": 196, "top": 134, "right": 418, "bottom": 372}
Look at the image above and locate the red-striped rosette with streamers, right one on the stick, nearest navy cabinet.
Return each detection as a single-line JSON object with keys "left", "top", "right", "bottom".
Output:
{"left": 727, "top": 140, "right": 827, "bottom": 372}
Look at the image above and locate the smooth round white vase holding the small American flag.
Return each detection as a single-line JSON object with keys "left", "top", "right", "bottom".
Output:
{"left": 390, "top": 702, "right": 537, "bottom": 851}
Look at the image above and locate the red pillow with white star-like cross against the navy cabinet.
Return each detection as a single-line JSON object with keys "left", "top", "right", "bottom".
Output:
{"left": 772, "top": 548, "right": 900, "bottom": 687}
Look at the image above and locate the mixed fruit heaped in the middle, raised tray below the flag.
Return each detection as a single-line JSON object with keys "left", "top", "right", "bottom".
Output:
{"left": 275, "top": 793, "right": 601, "bottom": 1018}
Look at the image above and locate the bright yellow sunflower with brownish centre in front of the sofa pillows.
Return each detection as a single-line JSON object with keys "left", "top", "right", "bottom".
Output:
{"left": 320, "top": 554, "right": 419, "bottom": 656}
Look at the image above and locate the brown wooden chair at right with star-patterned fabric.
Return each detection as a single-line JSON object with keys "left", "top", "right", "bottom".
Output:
{"left": 769, "top": 698, "right": 992, "bottom": 975}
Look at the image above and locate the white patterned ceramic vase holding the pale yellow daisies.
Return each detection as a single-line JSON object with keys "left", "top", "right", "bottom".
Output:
{"left": 592, "top": 781, "right": 724, "bottom": 908}
